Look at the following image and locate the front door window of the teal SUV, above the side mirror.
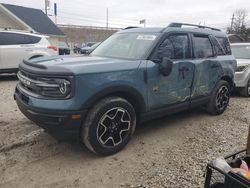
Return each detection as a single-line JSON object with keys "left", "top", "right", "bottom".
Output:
{"left": 157, "top": 34, "right": 190, "bottom": 59}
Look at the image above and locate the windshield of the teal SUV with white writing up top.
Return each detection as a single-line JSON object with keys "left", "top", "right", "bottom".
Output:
{"left": 91, "top": 33, "right": 158, "bottom": 59}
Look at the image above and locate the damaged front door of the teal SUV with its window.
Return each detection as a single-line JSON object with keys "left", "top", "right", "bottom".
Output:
{"left": 147, "top": 33, "right": 194, "bottom": 110}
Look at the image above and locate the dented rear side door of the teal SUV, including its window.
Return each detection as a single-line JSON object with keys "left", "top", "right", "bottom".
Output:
{"left": 192, "top": 34, "right": 223, "bottom": 99}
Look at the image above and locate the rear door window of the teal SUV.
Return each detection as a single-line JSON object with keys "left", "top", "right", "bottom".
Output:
{"left": 193, "top": 35, "right": 214, "bottom": 58}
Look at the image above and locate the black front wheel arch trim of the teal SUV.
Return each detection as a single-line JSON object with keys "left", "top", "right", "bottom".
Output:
{"left": 82, "top": 86, "right": 146, "bottom": 117}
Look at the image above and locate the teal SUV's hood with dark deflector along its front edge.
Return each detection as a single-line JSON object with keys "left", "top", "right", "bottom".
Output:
{"left": 20, "top": 56, "right": 140, "bottom": 75}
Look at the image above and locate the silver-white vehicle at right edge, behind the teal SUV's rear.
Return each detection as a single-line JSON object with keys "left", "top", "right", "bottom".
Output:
{"left": 231, "top": 43, "right": 250, "bottom": 97}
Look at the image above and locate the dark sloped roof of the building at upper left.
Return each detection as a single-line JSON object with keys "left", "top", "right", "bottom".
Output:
{"left": 2, "top": 4, "right": 64, "bottom": 36}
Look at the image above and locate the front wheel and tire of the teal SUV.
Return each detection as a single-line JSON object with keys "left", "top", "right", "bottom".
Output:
{"left": 81, "top": 97, "right": 136, "bottom": 156}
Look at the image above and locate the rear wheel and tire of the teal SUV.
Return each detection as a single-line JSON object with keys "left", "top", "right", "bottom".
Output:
{"left": 207, "top": 80, "right": 231, "bottom": 115}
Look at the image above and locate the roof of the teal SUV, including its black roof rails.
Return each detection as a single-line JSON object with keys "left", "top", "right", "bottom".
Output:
{"left": 119, "top": 22, "right": 226, "bottom": 37}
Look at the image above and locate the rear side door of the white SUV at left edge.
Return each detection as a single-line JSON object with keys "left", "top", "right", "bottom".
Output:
{"left": 1, "top": 32, "right": 32, "bottom": 69}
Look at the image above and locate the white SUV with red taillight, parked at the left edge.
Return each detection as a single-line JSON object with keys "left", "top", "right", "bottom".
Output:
{"left": 0, "top": 30, "right": 58, "bottom": 73}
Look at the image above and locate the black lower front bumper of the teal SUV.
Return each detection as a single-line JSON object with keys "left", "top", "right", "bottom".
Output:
{"left": 14, "top": 88, "right": 87, "bottom": 132}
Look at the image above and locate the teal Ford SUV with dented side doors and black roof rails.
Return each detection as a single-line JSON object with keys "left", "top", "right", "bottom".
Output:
{"left": 14, "top": 23, "right": 236, "bottom": 155}
